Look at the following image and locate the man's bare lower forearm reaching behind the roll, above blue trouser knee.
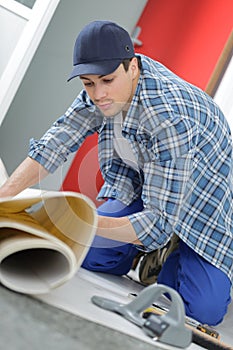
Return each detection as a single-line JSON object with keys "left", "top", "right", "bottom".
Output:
{"left": 96, "top": 216, "right": 142, "bottom": 245}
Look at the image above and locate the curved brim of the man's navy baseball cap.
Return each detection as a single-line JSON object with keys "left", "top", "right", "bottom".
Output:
{"left": 67, "top": 59, "right": 122, "bottom": 81}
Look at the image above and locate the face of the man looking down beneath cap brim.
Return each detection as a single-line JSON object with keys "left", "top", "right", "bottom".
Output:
{"left": 80, "top": 58, "right": 139, "bottom": 117}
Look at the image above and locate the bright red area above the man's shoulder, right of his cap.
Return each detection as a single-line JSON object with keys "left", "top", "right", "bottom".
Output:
{"left": 135, "top": 0, "right": 233, "bottom": 89}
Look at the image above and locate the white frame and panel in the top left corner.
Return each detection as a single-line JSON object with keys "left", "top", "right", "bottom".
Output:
{"left": 0, "top": 0, "right": 59, "bottom": 125}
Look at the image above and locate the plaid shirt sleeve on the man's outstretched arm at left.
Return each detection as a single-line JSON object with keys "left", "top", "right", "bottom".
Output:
{"left": 28, "top": 91, "right": 101, "bottom": 173}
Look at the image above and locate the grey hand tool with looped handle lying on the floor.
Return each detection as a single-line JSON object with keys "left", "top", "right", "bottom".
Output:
{"left": 91, "top": 284, "right": 192, "bottom": 348}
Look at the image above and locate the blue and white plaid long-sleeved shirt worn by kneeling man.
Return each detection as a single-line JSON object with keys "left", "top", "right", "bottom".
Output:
{"left": 29, "top": 55, "right": 233, "bottom": 280}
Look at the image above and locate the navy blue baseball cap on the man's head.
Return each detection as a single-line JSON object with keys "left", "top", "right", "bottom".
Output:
{"left": 68, "top": 21, "right": 135, "bottom": 81}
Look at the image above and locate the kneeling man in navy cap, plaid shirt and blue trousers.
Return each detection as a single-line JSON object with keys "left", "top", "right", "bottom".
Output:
{"left": 0, "top": 21, "right": 233, "bottom": 325}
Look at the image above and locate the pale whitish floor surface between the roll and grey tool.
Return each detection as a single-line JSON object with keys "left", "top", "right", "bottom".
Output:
{"left": 37, "top": 269, "right": 233, "bottom": 350}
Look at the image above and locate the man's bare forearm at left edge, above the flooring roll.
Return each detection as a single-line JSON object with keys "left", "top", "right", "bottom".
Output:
{"left": 0, "top": 157, "right": 48, "bottom": 197}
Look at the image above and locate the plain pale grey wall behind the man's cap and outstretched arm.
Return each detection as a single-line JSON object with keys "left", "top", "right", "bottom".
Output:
{"left": 0, "top": 0, "right": 146, "bottom": 188}
